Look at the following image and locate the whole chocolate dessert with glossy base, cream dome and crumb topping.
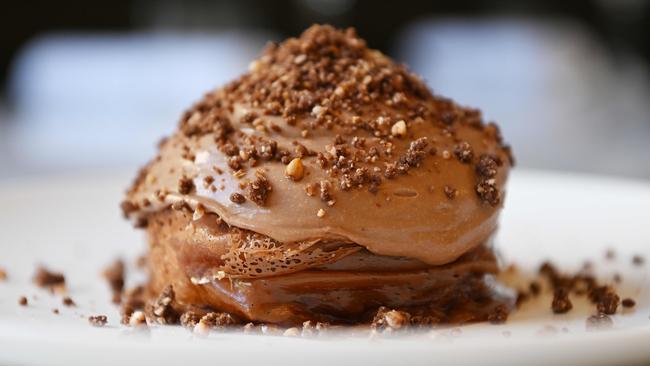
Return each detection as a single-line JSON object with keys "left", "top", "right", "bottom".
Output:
{"left": 122, "top": 25, "right": 513, "bottom": 325}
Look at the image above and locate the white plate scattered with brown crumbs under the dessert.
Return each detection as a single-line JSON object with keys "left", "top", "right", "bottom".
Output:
{"left": 0, "top": 171, "right": 650, "bottom": 365}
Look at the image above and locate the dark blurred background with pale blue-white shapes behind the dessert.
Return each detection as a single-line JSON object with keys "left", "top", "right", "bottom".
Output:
{"left": 0, "top": 0, "right": 650, "bottom": 180}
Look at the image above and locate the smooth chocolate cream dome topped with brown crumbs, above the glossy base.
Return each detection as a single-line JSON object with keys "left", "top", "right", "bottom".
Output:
{"left": 123, "top": 26, "right": 512, "bottom": 265}
